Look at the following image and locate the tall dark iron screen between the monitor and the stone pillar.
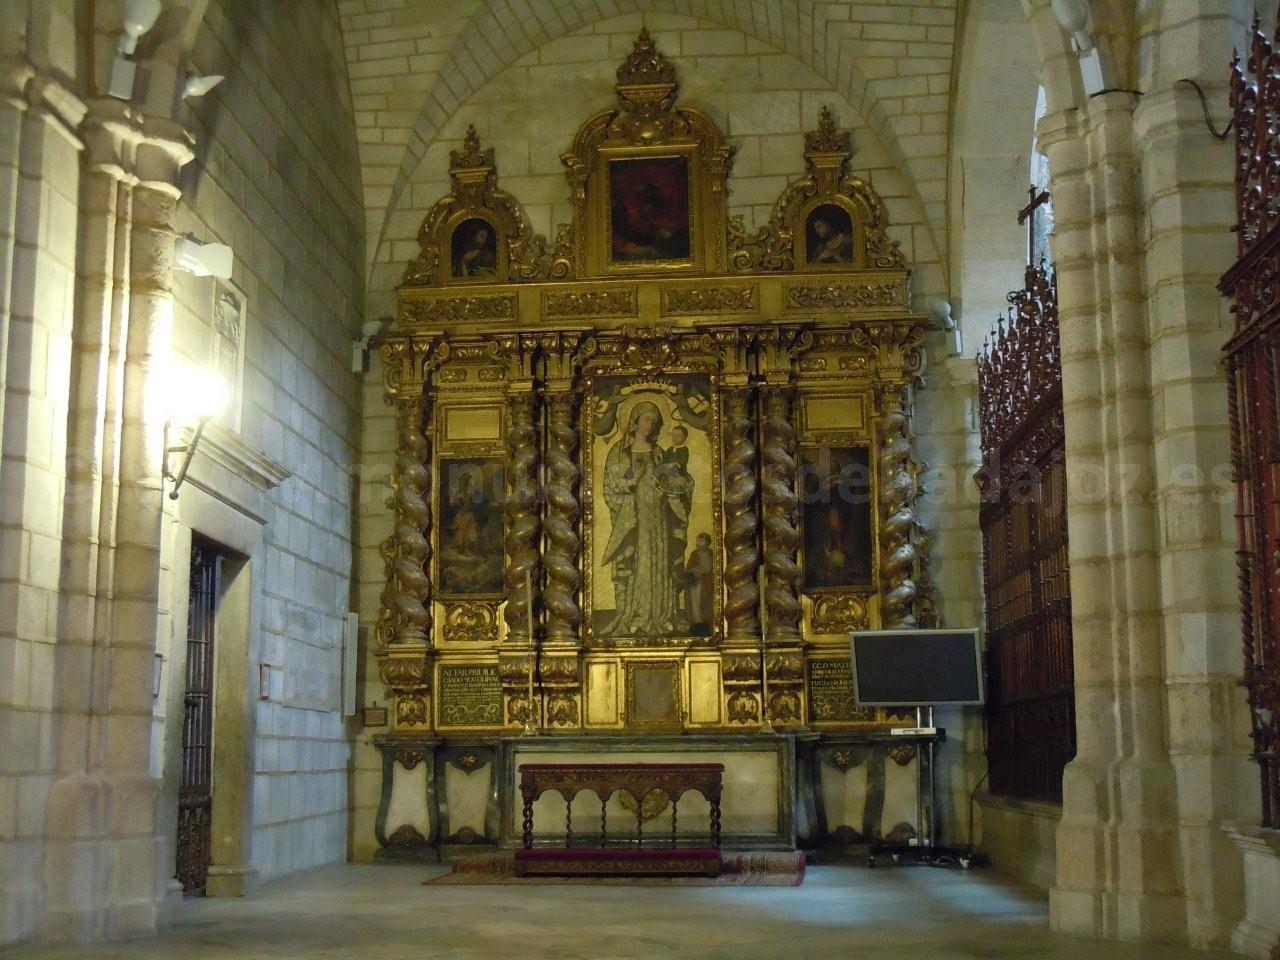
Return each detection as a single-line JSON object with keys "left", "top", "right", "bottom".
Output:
{"left": 978, "top": 264, "right": 1075, "bottom": 801}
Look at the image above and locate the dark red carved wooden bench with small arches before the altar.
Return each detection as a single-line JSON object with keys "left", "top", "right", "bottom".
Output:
{"left": 516, "top": 763, "right": 724, "bottom": 877}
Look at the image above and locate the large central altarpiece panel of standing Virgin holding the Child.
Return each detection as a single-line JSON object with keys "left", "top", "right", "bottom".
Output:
{"left": 589, "top": 374, "right": 719, "bottom": 643}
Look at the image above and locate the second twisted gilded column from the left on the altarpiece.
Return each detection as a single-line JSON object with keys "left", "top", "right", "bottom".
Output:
{"left": 503, "top": 390, "right": 540, "bottom": 644}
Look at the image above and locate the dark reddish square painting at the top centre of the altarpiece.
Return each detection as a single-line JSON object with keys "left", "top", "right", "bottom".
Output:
{"left": 609, "top": 156, "right": 690, "bottom": 264}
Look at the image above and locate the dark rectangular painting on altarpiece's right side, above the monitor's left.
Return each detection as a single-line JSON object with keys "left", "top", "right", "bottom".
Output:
{"left": 800, "top": 447, "right": 872, "bottom": 589}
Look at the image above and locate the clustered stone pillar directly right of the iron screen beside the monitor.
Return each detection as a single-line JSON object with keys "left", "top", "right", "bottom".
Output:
{"left": 1039, "top": 99, "right": 1184, "bottom": 940}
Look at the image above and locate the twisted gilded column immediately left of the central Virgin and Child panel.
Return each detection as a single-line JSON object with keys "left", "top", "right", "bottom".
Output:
{"left": 543, "top": 393, "right": 582, "bottom": 643}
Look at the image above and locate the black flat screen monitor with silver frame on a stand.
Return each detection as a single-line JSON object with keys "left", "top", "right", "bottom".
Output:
{"left": 851, "top": 630, "right": 983, "bottom": 707}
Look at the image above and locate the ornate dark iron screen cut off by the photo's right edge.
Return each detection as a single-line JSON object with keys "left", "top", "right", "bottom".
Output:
{"left": 1219, "top": 13, "right": 1280, "bottom": 827}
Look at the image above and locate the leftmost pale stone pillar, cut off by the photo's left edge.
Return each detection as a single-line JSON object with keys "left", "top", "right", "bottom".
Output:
{"left": 0, "top": 62, "right": 83, "bottom": 957}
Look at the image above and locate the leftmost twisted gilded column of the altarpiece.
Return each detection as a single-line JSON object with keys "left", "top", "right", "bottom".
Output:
{"left": 378, "top": 397, "right": 431, "bottom": 644}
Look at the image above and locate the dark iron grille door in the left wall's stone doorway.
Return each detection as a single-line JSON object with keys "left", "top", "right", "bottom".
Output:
{"left": 177, "top": 539, "right": 221, "bottom": 893}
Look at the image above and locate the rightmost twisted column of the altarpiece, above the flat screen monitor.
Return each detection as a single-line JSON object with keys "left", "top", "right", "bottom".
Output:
{"left": 879, "top": 387, "right": 916, "bottom": 627}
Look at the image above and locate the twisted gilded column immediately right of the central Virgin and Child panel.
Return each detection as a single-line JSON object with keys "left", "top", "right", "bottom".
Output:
{"left": 723, "top": 389, "right": 760, "bottom": 643}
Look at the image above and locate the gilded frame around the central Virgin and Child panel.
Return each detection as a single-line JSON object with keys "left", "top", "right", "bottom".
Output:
{"left": 579, "top": 360, "right": 724, "bottom": 649}
